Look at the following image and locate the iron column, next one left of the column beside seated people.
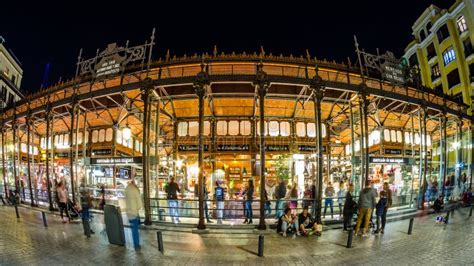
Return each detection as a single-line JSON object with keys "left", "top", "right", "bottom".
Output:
{"left": 194, "top": 62, "right": 209, "bottom": 230}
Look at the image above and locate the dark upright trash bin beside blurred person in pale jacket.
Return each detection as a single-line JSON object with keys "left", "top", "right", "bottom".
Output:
{"left": 104, "top": 205, "right": 125, "bottom": 246}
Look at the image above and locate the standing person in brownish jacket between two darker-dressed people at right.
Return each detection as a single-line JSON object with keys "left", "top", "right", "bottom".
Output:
{"left": 354, "top": 180, "right": 376, "bottom": 237}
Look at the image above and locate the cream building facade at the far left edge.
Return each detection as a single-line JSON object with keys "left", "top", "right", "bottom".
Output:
{"left": 0, "top": 36, "right": 23, "bottom": 108}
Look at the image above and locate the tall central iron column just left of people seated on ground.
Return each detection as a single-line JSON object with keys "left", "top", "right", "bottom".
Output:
{"left": 254, "top": 62, "right": 270, "bottom": 230}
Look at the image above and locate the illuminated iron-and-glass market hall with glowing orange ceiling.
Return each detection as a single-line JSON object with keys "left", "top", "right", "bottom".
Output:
{"left": 1, "top": 34, "right": 473, "bottom": 228}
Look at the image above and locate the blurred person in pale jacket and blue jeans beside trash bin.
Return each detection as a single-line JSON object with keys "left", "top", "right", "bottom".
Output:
{"left": 125, "top": 179, "right": 142, "bottom": 250}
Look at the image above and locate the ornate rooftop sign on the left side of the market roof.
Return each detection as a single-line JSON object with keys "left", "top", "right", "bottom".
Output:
{"left": 77, "top": 30, "right": 155, "bottom": 79}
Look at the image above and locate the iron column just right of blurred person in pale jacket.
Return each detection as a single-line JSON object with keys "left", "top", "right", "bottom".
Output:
{"left": 142, "top": 78, "right": 153, "bottom": 225}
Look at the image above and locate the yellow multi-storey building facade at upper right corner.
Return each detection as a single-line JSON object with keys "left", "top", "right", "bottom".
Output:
{"left": 404, "top": 0, "right": 474, "bottom": 112}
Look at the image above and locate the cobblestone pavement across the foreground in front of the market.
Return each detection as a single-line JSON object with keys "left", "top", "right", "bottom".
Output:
{"left": 0, "top": 206, "right": 474, "bottom": 265}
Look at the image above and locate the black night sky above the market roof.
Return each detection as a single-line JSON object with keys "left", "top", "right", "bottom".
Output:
{"left": 0, "top": 0, "right": 454, "bottom": 92}
